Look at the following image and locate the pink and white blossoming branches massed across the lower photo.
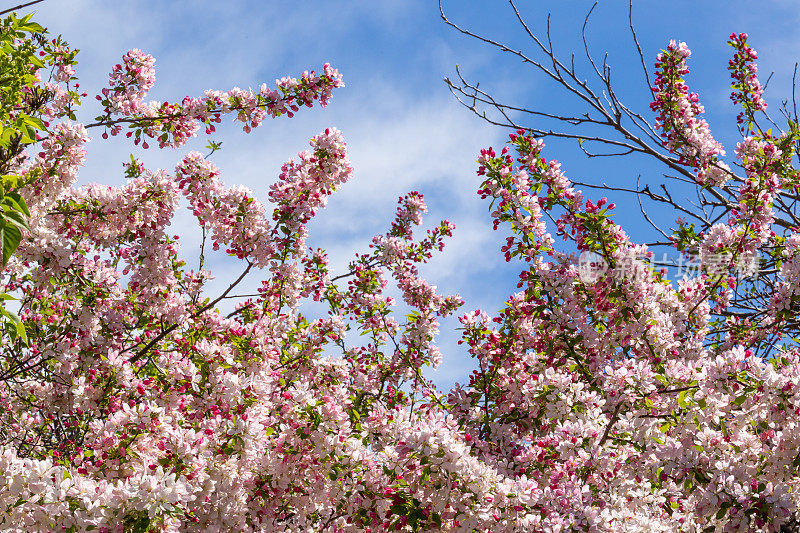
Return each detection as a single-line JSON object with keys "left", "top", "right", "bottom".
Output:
{"left": 0, "top": 5, "right": 800, "bottom": 532}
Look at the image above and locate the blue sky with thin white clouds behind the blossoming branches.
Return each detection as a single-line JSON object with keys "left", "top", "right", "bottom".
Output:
{"left": 21, "top": 0, "right": 800, "bottom": 386}
